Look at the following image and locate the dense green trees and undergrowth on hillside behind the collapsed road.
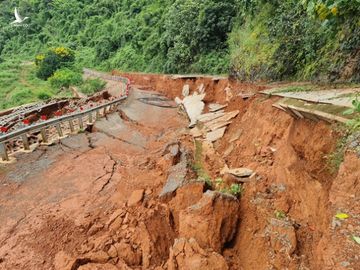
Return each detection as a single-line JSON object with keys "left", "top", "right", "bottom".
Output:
{"left": 0, "top": 0, "right": 360, "bottom": 107}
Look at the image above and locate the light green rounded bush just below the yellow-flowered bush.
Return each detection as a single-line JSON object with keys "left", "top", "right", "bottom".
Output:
{"left": 49, "top": 68, "right": 83, "bottom": 88}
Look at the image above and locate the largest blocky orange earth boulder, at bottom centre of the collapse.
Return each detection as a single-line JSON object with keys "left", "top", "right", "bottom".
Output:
{"left": 179, "top": 191, "right": 239, "bottom": 252}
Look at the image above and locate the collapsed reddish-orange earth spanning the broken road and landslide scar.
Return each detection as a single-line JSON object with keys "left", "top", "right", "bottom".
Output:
{"left": 0, "top": 74, "right": 360, "bottom": 270}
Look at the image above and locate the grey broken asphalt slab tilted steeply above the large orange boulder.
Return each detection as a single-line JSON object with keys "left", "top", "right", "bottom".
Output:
{"left": 159, "top": 152, "right": 188, "bottom": 197}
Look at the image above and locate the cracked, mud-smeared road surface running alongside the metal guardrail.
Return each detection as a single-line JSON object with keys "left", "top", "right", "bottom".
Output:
{"left": 0, "top": 90, "right": 186, "bottom": 269}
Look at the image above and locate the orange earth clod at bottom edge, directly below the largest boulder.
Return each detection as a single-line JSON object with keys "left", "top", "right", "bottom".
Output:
{"left": 167, "top": 238, "right": 229, "bottom": 270}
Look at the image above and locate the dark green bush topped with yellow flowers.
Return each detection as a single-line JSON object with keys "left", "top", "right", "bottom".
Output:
{"left": 35, "top": 47, "right": 75, "bottom": 80}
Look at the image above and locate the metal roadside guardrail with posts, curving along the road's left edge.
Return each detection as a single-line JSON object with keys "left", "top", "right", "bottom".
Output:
{"left": 0, "top": 69, "right": 130, "bottom": 161}
